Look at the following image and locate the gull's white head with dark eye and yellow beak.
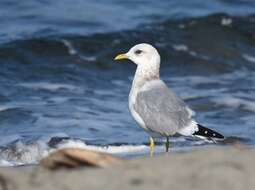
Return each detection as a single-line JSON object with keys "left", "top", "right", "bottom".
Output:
{"left": 114, "top": 43, "right": 160, "bottom": 77}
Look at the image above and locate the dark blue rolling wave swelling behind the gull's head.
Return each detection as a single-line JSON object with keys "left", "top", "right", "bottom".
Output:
{"left": 0, "top": 14, "right": 254, "bottom": 72}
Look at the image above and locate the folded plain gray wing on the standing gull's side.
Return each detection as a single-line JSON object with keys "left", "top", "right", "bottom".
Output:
{"left": 134, "top": 80, "right": 192, "bottom": 136}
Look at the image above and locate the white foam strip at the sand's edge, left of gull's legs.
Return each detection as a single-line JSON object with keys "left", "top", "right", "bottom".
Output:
{"left": 0, "top": 140, "right": 149, "bottom": 166}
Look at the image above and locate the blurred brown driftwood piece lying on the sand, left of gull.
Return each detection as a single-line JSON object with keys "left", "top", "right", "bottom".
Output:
{"left": 40, "top": 148, "right": 123, "bottom": 170}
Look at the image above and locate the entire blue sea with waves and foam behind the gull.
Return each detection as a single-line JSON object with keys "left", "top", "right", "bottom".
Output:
{"left": 0, "top": 0, "right": 255, "bottom": 165}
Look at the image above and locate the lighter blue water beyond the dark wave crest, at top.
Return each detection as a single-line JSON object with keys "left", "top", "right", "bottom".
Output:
{"left": 0, "top": 0, "right": 255, "bottom": 42}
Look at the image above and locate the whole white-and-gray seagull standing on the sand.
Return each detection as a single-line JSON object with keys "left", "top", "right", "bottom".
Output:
{"left": 114, "top": 43, "right": 224, "bottom": 156}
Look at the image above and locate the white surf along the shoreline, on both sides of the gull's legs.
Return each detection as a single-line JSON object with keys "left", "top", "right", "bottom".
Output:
{"left": 0, "top": 137, "right": 215, "bottom": 166}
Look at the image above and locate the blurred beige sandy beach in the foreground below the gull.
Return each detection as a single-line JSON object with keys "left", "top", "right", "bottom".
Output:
{"left": 0, "top": 148, "right": 255, "bottom": 190}
